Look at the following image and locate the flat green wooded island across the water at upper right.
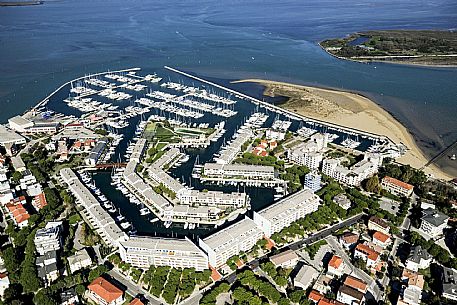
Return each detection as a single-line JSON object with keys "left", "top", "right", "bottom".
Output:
{"left": 319, "top": 30, "right": 457, "bottom": 66}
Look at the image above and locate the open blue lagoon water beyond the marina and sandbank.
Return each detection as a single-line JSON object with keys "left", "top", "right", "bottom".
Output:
{"left": 0, "top": 0, "right": 457, "bottom": 174}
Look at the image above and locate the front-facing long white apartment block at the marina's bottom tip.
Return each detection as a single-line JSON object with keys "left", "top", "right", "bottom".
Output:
{"left": 119, "top": 237, "right": 208, "bottom": 271}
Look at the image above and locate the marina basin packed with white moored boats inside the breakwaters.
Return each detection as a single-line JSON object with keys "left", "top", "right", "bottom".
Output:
{"left": 2, "top": 67, "right": 402, "bottom": 241}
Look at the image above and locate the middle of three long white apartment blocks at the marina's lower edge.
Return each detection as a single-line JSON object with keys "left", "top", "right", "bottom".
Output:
{"left": 199, "top": 217, "right": 263, "bottom": 267}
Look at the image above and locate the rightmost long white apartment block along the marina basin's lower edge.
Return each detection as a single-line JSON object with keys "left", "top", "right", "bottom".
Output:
{"left": 254, "top": 188, "right": 319, "bottom": 237}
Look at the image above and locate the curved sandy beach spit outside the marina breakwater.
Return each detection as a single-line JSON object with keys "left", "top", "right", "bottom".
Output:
{"left": 238, "top": 79, "right": 452, "bottom": 180}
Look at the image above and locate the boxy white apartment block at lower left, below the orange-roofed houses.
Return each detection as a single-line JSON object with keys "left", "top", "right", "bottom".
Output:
{"left": 34, "top": 221, "right": 62, "bottom": 255}
